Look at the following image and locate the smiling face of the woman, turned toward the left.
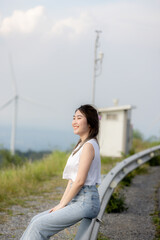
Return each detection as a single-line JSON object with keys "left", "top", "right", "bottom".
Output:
{"left": 72, "top": 110, "right": 90, "bottom": 141}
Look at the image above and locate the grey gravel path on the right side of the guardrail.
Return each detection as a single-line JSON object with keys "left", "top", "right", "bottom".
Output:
{"left": 100, "top": 167, "right": 160, "bottom": 240}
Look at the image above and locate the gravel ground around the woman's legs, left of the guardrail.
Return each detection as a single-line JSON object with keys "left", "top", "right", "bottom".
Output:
{"left": 0, "top": 187, "right": 78, "bottom": 240}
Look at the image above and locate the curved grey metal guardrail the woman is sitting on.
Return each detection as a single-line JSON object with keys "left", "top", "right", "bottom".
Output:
{"left": 75, "top": 145, "right": 160, "bottom": 240}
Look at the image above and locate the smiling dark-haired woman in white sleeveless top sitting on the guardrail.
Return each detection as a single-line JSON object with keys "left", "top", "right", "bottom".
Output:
{"left": 21, "top": 105, "right": 101, "bottom": 240}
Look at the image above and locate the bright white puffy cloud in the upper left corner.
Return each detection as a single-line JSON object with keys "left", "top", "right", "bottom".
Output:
{"left": 0, "top": 6, "right": 44, "bottom": 35}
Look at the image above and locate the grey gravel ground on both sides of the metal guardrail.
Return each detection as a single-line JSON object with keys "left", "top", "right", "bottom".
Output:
{"left": 0, "top": 167, "right": 160, "bottom": 240}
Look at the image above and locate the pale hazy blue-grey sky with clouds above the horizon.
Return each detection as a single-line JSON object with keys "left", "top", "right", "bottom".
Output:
{"left": 0, "top": 0, "right": 160, "bottom": 148}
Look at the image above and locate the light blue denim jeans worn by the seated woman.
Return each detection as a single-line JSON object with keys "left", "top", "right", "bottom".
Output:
{"left": 21, "top": 185, "right": 100, "bottom": 240}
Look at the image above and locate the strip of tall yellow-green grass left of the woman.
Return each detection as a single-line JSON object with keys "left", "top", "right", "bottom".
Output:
{"left": 0, "top": 151, "right": 68, "bottom": 208}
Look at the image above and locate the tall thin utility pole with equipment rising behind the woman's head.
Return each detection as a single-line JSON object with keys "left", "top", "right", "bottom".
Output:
{"left": 92, "top": 30, "right": 104, "bottom": 105}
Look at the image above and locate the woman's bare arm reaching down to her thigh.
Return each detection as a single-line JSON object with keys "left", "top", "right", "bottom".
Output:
{"left": 51, "top": 143, "right": 95, "bottom": 212}
